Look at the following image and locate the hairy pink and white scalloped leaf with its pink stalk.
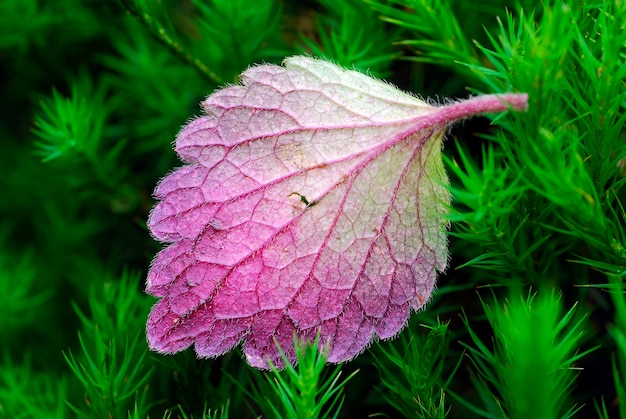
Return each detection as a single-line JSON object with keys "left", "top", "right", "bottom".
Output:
{"left": 147, "top": 57, "right": 527, "bottom": 368}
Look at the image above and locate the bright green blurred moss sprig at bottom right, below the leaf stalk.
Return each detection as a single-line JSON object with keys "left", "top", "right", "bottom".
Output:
{"left": 456, "top": 292, "right": 590, "bottom": 418}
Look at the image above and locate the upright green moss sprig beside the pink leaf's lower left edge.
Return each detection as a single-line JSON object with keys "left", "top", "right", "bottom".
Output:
{"left": 65, "top": 272, "right": 151, "bottom": 417}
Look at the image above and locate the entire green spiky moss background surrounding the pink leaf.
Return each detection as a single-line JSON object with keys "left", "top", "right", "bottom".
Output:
{"left": 0, "top": 0, "right": 626, "bottom": 418}
